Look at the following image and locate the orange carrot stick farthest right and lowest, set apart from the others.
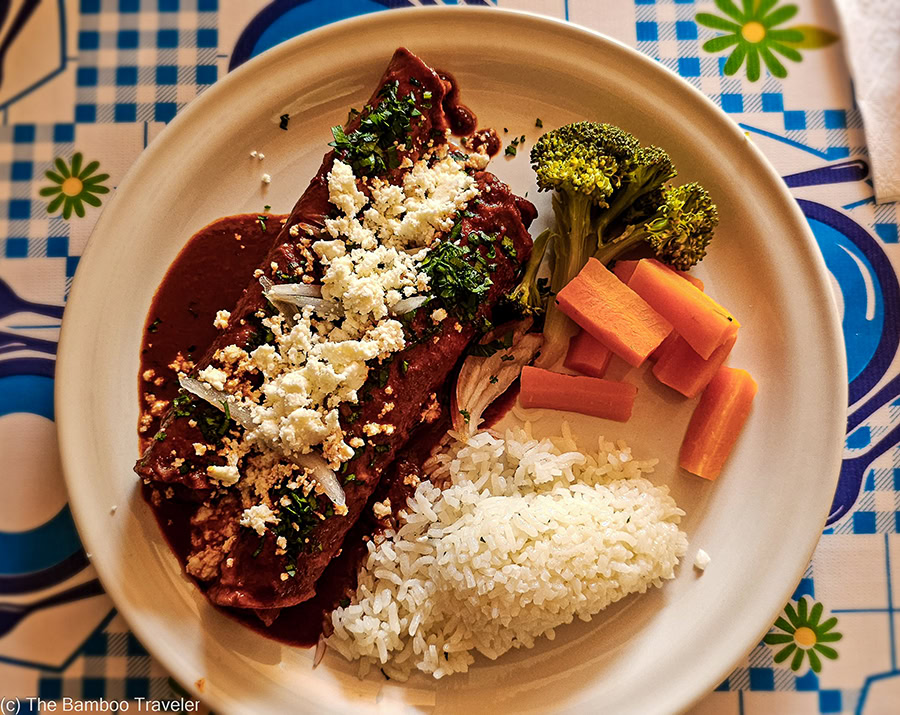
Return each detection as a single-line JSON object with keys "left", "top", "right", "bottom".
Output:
{"left": 678, "top": 366, "right": 757, "bottom": 479}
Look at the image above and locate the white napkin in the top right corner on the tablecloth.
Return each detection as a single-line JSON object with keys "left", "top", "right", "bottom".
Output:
{"left": 835, "top": 0, "right": 900, "bottom": 204}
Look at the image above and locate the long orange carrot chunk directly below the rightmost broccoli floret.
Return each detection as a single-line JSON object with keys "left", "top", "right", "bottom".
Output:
{"left": 628, "top": 258, "right": 740, "bottom": 359}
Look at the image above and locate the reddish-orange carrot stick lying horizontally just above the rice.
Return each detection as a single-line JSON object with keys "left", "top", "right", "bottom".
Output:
{"left": 519, "top": 365, "right": 637, "bottom": 422}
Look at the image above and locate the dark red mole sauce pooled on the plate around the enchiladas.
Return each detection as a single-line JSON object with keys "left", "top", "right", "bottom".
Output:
{"left": 138, "top": 214, "right": 517, "bottom": 646}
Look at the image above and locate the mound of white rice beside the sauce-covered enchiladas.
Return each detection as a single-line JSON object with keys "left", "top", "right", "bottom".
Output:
{"left": 328, "top": 424, "right": 687, "bottom": 680}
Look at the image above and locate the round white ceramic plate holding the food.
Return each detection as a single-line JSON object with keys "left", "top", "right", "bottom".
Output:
{"left": 57, "top": 8, "right": 846, "bottom": 713}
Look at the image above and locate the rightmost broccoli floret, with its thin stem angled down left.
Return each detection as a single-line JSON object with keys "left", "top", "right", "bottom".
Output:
{"left": 594, "top": 183, "right": 719, "bottom": 271}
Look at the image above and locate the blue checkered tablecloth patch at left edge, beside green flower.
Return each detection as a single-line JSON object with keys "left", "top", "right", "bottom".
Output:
{"left": 0, "top": 124, "right": 78, "bottom": 280}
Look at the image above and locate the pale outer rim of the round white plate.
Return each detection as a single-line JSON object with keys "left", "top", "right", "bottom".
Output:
{"left": 54, "top": 6, "right": 848, "bottom": 711}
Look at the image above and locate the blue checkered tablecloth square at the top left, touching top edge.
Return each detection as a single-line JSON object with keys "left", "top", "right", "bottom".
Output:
{"left": 75, "top": 0, "right": 219, "bottom": 123}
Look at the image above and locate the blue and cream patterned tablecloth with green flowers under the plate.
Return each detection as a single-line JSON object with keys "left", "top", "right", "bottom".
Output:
{"left": 0, "top": 0, "right": 900, "bottom": 714}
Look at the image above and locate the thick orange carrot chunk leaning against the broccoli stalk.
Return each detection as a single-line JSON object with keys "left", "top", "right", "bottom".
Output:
{"left": 556, "top": 258, "right": 672, "bottom": 367}
